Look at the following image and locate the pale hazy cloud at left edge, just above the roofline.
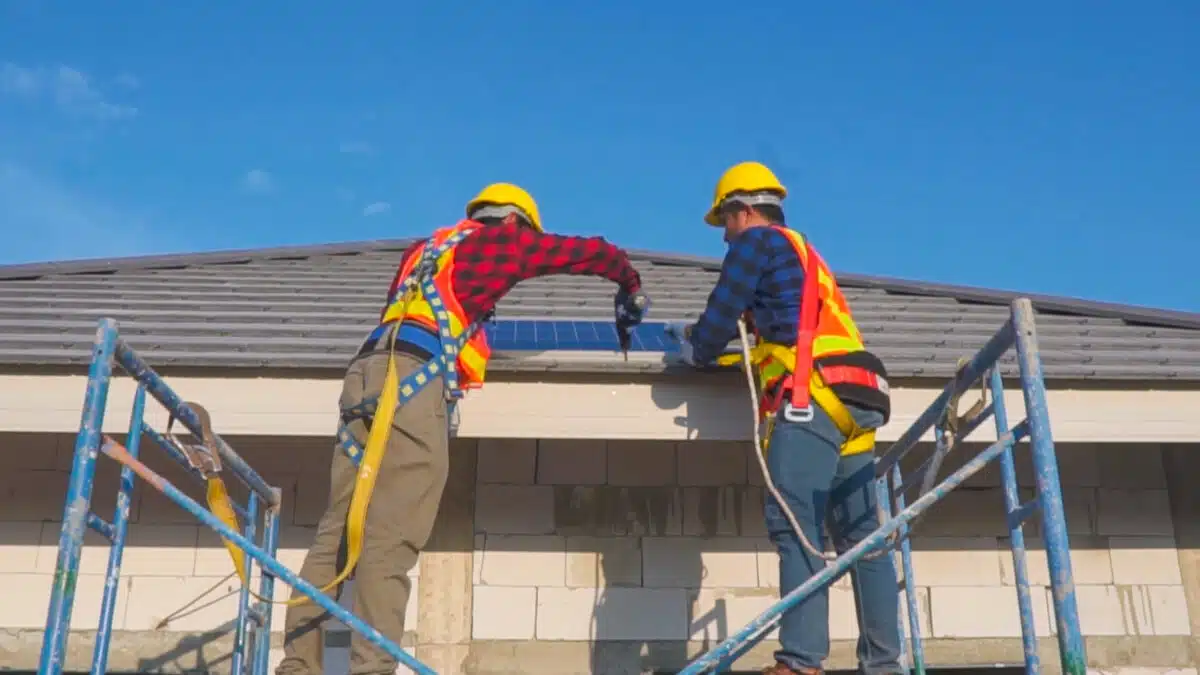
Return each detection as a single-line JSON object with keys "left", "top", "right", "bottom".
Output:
{"left": 0, "top": 160, "right": 186, "bottom": 263}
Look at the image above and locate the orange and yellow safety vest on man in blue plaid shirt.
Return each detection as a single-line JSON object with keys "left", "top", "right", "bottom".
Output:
{"left": 719, "top": 225, "right": 890, "bottom": 454}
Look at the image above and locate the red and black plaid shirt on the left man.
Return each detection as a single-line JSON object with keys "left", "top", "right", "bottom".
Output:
{"left": 380, "top": 221, "right": 642, "bottom": 322}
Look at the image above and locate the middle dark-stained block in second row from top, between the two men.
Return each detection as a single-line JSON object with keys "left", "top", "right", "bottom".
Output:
{"left": 553, "top": 485, "right": 683, "bottom": 537}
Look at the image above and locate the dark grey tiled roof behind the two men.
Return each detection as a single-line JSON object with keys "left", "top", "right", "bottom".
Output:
{"left": 0, "top": 240, "right": 1200, "bottom": 382}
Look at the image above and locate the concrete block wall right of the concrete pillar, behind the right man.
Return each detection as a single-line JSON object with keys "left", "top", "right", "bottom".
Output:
{"left": 473, "top": 440, "right": 1190, "bottom": 641}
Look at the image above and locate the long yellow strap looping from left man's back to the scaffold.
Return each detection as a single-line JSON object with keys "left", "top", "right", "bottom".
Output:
{"left": 206, "top": 289, "right": 414, "bottom": 607}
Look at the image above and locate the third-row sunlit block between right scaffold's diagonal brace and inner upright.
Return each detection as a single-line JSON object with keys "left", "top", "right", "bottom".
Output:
{"left": 912, "top": 537, "right": 1001, "bottom": 586}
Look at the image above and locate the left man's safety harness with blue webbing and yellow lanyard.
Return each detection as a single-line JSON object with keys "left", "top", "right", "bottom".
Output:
{"left": 189, "top": 228, "right": 480, "bottom": 607}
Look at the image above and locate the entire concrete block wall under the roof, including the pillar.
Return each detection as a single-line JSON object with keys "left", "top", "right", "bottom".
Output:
{"left": 0, "top": 434, "right": 1200, "bottom": 673}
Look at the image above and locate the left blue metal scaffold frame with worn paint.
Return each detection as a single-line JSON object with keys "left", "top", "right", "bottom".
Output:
{"left": 37, "top": 318, "right": 436, "bottom": 675}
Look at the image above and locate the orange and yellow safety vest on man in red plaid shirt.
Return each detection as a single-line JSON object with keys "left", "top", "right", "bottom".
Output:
{"left": 379, "top": 220, "right": 492, "bottom": 389}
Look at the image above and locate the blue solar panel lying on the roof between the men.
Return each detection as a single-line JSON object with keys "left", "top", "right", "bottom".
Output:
{"left": 484, "top": 319, "right": 679, "bottom": 352}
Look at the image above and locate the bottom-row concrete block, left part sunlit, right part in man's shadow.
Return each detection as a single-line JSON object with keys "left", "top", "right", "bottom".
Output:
{"left": 538, "top": 587, "right": 688, "bottom": 640}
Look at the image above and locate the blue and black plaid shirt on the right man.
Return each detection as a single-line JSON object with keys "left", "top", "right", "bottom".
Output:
{"left": 691, "top": 227, "right": 804, "bottom": 364}
